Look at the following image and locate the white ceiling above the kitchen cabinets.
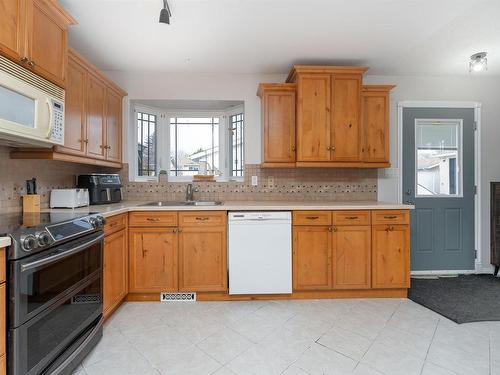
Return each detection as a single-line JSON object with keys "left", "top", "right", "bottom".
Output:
{"left": 60, "top": 0, "right": 500, "bottom": 75}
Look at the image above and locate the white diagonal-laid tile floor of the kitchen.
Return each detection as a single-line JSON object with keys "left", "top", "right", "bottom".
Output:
{"left": 72, "top": 299, "right": 500, "bottom": 375}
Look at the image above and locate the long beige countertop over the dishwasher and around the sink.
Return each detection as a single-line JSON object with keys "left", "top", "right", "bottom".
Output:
{"left": 45, "top": 201, "right": 414, "bottom": 216}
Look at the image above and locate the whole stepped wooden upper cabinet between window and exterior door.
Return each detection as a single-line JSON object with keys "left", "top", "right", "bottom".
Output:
{"left": 258, "top": 65, "right": 394, "bottom": 168}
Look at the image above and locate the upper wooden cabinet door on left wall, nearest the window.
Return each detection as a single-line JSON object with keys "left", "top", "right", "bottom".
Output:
{"left": 105, "top": 88, "right": 122, "bottom": 162}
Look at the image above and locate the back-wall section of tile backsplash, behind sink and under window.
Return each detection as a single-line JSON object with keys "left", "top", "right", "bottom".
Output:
{"left": 122, "top": 164, "right": 377, "bottom": 201}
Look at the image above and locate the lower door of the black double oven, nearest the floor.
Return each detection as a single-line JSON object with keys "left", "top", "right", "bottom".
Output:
{"left": 8, "top": 275, "right": 102, "bottom": 375}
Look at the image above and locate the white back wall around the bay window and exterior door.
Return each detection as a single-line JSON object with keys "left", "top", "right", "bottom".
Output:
{"left": 106, "top": 71, "right": 500, "bottom": 266}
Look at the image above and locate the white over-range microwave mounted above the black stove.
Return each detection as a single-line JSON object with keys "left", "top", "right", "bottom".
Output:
{"left": 0, "top": 56, "right": 65, "bottom": 147}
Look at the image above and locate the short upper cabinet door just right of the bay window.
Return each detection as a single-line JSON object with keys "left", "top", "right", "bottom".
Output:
{"left": 262, "top": 91, "right": 295, "bottom": 163}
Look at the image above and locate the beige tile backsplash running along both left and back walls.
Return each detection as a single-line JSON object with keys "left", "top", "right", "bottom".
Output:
{"left": 0, "top": 146, "right": 377, "bottom": 212}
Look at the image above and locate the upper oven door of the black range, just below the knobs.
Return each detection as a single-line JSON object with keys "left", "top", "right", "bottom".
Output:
{"left": 9, "top": 231, "right": 104, "bottom": 328}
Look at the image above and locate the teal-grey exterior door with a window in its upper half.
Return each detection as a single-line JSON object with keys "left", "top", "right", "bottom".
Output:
{"left": 402, "top": 108, "right": 475, "bottom": 271}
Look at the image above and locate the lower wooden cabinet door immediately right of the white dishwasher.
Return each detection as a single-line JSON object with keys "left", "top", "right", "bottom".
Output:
{"left": 293, "top": 226, "right": 332, "bottom": 290}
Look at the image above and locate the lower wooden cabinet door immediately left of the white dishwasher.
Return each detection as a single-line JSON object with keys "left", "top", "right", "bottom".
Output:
{"left": 179, "top": 226, "right": 227, "bottom": 292}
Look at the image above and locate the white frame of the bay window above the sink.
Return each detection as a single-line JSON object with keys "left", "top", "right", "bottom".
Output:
{"left": 128, "top": 103, "right": 246, "bottom": 182}
